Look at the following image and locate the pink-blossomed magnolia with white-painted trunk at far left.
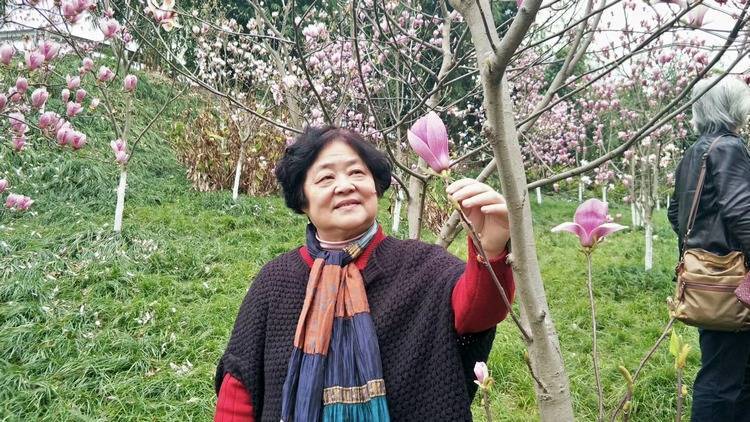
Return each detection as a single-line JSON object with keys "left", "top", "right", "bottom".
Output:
{"left": 0, "top": 0, "right": 184, "bottom": 232}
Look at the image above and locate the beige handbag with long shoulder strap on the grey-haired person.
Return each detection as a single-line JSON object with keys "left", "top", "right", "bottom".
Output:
{"left": 668, "top": 138, "right": 750, "bottom": 331}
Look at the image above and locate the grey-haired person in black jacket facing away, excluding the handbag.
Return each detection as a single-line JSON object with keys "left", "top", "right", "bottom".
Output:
{"left": 668, "top": 77, "right": 750, "bottom": 422}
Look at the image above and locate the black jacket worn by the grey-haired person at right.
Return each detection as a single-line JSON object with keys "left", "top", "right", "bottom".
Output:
{"left": 667, "top": 131, "right": 750, "bottom": 257}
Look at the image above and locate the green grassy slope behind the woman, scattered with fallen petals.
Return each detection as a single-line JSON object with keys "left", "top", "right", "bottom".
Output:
{"left": 0, "top": 78, "right": 698, "bottom": 421}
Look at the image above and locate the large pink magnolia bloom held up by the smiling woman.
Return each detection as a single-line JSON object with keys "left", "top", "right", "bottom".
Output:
{"left": 406, "top": 111, "right": 450, "bottom": 173}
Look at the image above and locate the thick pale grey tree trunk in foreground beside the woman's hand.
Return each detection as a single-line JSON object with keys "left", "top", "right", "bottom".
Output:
{"left": 451, "top": 0, "right": 573, "bottom": 416}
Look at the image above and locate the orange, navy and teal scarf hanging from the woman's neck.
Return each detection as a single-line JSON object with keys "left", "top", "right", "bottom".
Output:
{"left": 281, "top": 222, "right": 390, "bottom": 422}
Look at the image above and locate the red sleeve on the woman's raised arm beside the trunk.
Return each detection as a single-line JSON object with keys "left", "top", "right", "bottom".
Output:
{"left": 451, "top": 239, "right": 515, "bottom": 334}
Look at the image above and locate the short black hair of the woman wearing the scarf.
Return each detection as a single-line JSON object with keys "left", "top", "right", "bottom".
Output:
{"left": 276, "top": 126, "right": 393, "bottom": 214}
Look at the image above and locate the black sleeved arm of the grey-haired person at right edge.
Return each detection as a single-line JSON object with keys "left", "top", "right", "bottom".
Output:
{"left": 709, "top": 139, "right": 750, "bottom": 256}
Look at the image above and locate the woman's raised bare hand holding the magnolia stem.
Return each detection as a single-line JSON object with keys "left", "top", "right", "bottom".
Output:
{"left": 446, "top": 178, "right": 510, "bottom": 258}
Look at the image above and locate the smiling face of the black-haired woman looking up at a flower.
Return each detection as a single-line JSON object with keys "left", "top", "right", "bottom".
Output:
{"left": 302, "top": 141, "right": 378, "bottom": 242}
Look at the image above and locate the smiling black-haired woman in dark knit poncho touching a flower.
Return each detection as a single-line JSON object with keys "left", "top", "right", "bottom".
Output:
{"left": 215, "top": 127, "right": 514, "bottom": 422}
